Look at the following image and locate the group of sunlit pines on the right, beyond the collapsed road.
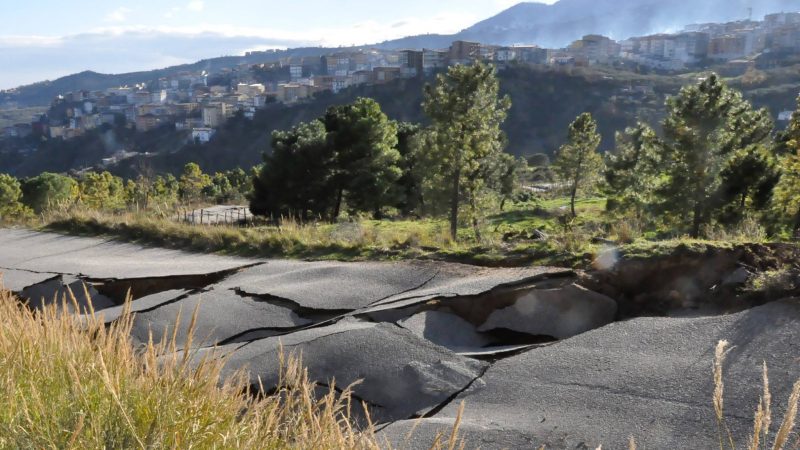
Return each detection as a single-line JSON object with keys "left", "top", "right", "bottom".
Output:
{"left": 554, "top": 75, "right": 800, "bottom": 237}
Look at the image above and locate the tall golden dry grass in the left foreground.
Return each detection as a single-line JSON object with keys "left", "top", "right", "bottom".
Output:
{"left": 0, "top": 287, "right": 461, "bottom": 450}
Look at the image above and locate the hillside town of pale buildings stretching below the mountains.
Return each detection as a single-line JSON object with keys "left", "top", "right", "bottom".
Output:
{"left": 0, "top": 13, "right": 800, "bottom": 143}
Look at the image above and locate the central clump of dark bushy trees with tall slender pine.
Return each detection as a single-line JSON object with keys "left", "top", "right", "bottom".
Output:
{"left": 250, "top": 64, "right": 524, "bottom": 239}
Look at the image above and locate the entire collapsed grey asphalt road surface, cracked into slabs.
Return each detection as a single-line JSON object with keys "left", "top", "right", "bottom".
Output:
{"left": 0, "top": 230, "right": 800, "bottom": 449}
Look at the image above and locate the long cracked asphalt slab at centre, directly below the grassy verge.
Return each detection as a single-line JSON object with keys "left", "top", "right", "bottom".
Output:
{"left": 220, "top": 261, "right": 574, "bottom": 311}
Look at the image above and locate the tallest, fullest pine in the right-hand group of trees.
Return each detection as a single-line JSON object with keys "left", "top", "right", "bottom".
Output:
{"left": 659, "top": 74, "right": 772, "bottom": 237}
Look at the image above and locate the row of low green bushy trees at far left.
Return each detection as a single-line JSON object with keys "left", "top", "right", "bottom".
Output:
{"left": 0, "top": 163, "right": 252, "bottom": 220}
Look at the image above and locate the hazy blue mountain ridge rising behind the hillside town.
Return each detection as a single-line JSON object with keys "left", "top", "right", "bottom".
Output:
{"left": 0, "top": 0, "right": 800, "bottom": 106}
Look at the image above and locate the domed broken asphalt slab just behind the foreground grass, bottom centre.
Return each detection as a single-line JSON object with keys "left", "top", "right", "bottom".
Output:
{"left": 200, "top": 319, "right": 487, "bottom": 422}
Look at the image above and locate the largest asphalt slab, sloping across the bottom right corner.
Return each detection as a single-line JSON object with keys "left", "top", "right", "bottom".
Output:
{"left": 381, "top": 300, "right": 800, "bottom": 449}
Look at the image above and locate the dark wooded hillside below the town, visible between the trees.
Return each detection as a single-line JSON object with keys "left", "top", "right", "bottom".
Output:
{"left": 0, "top": 66, "right": 800, "bottom": 176}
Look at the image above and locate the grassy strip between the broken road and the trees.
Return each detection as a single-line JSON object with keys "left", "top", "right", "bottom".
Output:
{"left": 34, "top": 197, "right": 740, "bottom": 268}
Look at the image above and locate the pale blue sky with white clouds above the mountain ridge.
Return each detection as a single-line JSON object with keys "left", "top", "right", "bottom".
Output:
{"left": 0, "top": 0, "right": 554, "bottom": 89}
